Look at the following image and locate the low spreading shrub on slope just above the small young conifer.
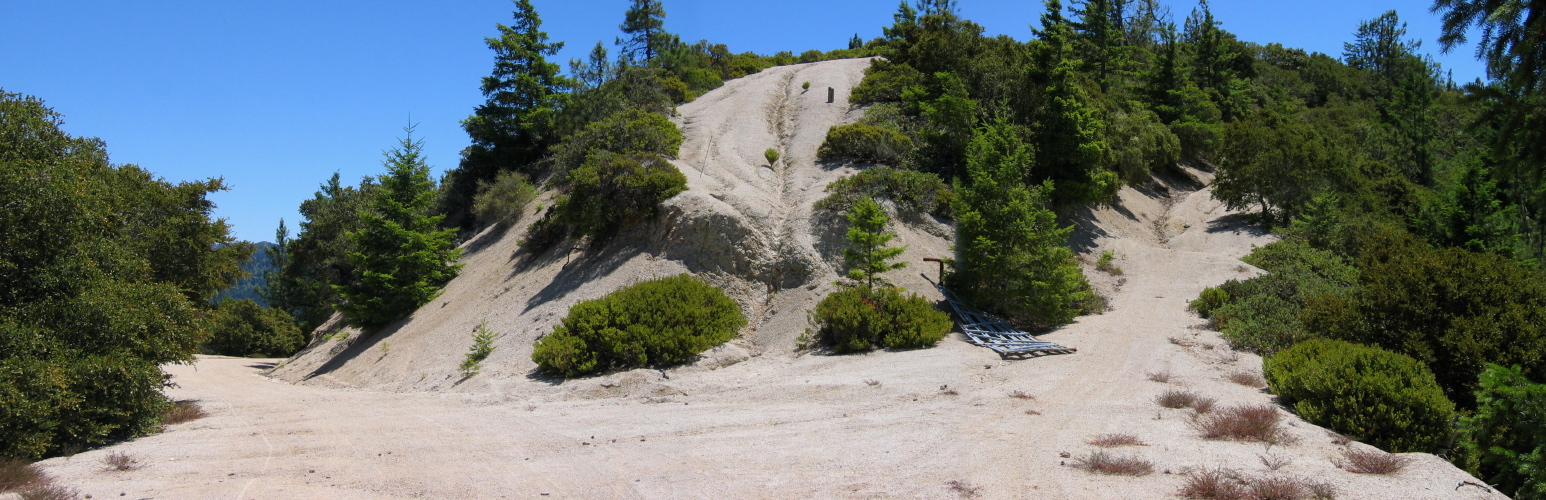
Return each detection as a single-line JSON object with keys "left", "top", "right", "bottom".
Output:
{"left": 816, "top": 166, "right": 955, "bottom": 217}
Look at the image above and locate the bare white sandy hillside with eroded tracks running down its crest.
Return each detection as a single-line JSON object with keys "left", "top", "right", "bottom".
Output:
{"left": 274, "top": 59, "right": 951, "bottom": 392}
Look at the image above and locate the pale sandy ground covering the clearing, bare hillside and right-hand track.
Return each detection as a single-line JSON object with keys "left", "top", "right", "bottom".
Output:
{"left": 30, "top": 60, "right": 1501, "bottom": 498}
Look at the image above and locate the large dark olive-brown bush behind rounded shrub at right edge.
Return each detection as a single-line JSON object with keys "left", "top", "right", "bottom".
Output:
{"left": 1302, "top": 235, "right": 1546, "bottom": 409}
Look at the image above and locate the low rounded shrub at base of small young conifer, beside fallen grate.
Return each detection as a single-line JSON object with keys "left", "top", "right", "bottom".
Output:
{"left": 807, "top": 286, "right": 954, "bottom": 353}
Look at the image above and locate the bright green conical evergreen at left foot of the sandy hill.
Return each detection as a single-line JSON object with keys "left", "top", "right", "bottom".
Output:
{"left": 335, "top": 125, "right": 462, "bottom": 330}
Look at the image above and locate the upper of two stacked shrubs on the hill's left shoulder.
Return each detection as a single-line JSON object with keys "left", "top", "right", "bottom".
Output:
{"left": 552, "top": 110, "right": 682, "bottom": 181}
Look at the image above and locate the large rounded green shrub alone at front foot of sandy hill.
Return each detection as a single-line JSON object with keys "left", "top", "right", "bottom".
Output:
{"left": 532, "top": 274, "right": 747, "bottom": 376}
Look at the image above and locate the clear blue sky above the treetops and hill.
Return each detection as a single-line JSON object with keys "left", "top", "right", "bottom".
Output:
{"left": 0, "top": 0, "right": 1483, "bottom": 240}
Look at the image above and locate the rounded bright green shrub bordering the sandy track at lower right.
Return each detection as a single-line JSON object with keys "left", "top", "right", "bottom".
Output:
{"left": 1263, "top": 339, "right": 1455, "bottom": 452}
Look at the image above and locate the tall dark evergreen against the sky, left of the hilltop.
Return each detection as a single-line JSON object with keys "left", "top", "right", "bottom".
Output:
{"left": 442, "top": 0, "right": 572, "bottom": 228}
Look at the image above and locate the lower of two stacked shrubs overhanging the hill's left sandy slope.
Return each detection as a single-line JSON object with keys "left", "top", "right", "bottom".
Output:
{"left": 553, "top": 152, "right": 686, "bottom": 237}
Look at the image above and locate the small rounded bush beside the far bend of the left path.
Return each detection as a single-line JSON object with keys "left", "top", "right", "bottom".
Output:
{"left": 204, "top": 300, "right": 306, "bottom": 358}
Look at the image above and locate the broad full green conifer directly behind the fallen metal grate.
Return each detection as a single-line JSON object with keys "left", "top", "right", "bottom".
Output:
{"left": 945, "top": 125, "right": 1093, "bottom": 327}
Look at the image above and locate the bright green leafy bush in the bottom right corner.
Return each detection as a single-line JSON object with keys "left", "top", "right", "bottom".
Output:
{"left": 1461, "top": 364, "right": 1546, "bottom": 500}
